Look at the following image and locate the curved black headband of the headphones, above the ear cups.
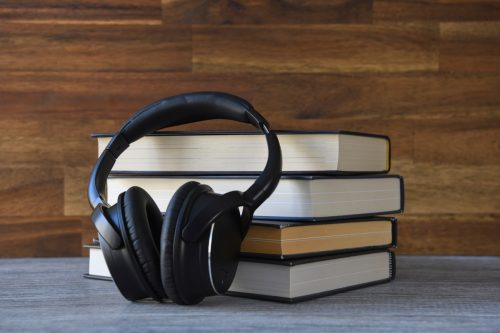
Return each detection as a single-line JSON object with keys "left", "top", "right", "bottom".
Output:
{"left": 88, "top": 92, "right": 281, "bottom": 213}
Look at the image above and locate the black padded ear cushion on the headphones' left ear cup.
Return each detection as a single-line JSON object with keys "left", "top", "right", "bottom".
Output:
{"left": 122, "top": 186, "right": 167, "bottom": 300}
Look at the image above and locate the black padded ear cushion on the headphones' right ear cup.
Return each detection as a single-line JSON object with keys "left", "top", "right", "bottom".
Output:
{"left": 160, "top": 182, "right": 205, "bottom": 304}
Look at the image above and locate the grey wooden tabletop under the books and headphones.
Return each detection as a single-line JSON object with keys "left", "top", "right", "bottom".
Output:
{"left": 0, "top": 257, "right": 500, "bottom": 333}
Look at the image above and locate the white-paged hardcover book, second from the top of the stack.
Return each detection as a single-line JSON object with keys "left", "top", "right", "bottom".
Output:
{"left": 107, "top": 174, "right": 404, "bottom": 220}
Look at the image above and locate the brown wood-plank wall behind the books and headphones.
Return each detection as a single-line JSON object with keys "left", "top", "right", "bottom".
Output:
{"left": 0, "top": 0, "right": 500, "bottom": 257}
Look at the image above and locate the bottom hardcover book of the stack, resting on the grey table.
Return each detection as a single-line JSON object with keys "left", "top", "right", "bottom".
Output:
{"left": 84, "top": 245, "right": 396, "bottom": 302}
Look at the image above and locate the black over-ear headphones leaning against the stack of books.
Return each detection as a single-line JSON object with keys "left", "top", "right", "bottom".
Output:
{"left": 88, "top": 92, "right": 281, "bottom": 304}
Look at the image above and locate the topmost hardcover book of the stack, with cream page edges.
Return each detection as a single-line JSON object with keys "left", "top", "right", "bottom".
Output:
{"left": 94, "top": 131, "right": 390, "bottom": 174}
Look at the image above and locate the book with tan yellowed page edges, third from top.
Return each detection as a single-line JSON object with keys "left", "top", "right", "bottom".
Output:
{"left": 241, "top": 217, "right": 397, "bottom": 259}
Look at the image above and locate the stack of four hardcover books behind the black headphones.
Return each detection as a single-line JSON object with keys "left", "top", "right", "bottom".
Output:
{"left": 87, "top": 131, "right": 404, "bottom": 302}
